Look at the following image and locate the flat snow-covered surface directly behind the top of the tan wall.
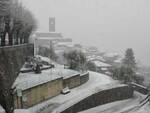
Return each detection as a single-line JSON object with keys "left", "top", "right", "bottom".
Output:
{"left": 12, "top": 68, "right": 79, "bottom": 90}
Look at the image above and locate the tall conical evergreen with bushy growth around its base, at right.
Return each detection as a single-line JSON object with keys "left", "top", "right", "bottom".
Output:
{"left": 112, "top": 48, "right": 138, "bottom": 83}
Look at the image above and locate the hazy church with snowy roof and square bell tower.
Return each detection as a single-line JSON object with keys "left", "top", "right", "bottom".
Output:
{"left": 31, "top": 17, "right": 72, "bottom": 54}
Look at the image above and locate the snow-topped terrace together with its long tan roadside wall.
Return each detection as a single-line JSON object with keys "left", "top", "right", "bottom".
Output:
{"left": 12, "top": 68, "right": 89, "bottom": 109}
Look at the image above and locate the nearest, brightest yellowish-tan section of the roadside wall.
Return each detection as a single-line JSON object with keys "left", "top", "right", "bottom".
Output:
{"left": 14, "top": 78, "right": 63, "bottom": 109}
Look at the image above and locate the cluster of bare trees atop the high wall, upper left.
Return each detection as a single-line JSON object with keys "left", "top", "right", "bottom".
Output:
{"left": 0, "top": 0, "right": 36, "bottom": 46}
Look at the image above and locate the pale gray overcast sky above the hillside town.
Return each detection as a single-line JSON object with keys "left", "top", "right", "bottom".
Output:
{"left": 20, "top": 0, "right": 150, "bottom": 66}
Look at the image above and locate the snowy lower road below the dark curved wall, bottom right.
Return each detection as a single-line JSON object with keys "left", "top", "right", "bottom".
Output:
{"left": 79, "top": 92, "right": 150, "bottom": 113}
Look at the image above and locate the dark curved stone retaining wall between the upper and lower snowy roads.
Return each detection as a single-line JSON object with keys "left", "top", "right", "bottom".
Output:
{"left": 61, "top": 85, "right": 133, "bottom": 113}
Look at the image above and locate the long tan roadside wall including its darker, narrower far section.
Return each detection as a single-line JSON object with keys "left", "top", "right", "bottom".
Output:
{"left": 14, "top": 74, "right": 89, "bottom": 109}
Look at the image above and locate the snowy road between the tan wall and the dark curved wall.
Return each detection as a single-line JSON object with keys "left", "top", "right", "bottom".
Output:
{"left": 15, "top": 71, "right": 118, "bottom": 113}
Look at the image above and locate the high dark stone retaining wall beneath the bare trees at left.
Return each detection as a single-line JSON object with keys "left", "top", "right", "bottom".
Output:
{"left": 0, "top": 44, "right": 34, "bottom": 86}
